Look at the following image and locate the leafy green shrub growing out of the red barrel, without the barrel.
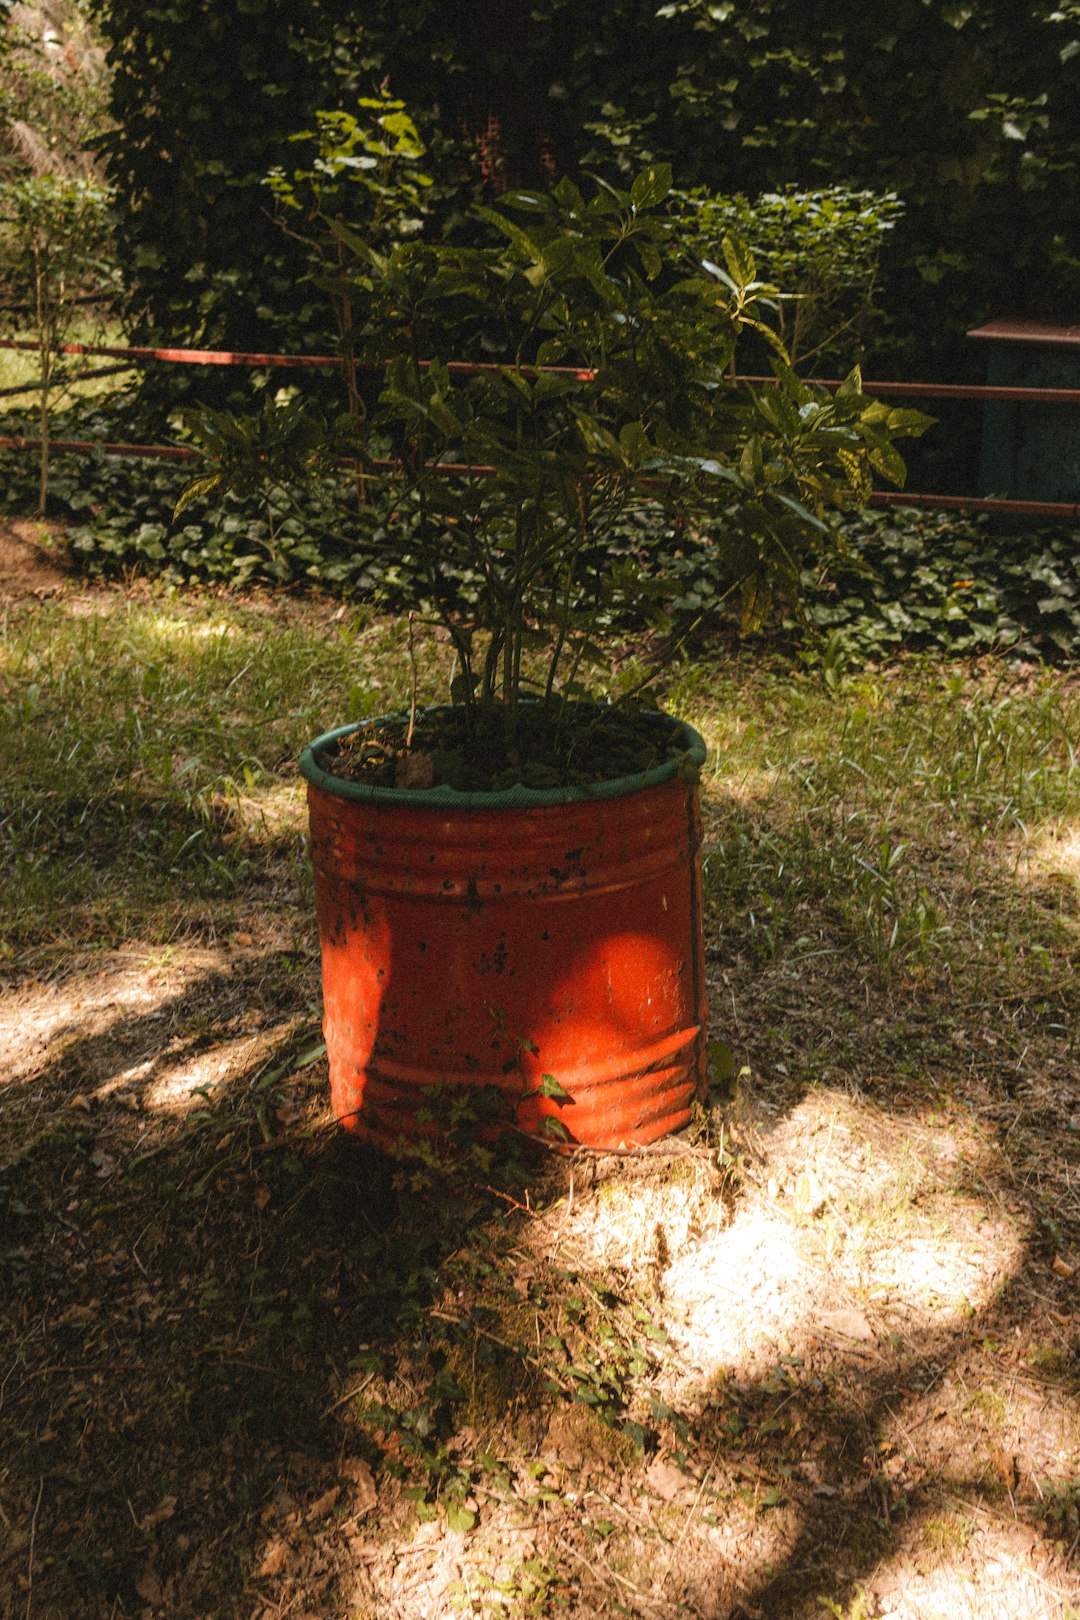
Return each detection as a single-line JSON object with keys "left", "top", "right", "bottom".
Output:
{"left": 180, "top": 165, "right": 926, "bottom": 779}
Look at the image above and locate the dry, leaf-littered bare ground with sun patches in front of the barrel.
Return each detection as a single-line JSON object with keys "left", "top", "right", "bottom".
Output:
{"left": 0, "top": 560, "right": 1080, "bottom": 1620}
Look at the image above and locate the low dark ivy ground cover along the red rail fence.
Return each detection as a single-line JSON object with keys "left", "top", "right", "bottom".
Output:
{"left": 0, "top": 407, "right": 1080, "bottom": 669}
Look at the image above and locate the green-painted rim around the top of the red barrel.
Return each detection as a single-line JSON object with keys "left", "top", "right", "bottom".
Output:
{"left": 300, "top": 710, "right": 708, "bottom": 810}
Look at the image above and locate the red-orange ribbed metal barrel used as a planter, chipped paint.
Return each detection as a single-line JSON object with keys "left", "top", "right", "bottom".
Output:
{"left": 301, "top": 716, "right": 708, "bottom": 1149}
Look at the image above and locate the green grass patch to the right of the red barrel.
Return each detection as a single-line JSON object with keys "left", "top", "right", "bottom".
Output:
{"left": 670, "top": 648, "right": 1080, "bottom": 975}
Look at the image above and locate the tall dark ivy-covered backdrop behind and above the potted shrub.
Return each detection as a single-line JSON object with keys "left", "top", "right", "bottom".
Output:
{"left": 97, "top": 0, "right": 1080, "bottom": 392}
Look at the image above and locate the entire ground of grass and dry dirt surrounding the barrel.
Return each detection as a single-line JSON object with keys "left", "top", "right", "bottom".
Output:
{"left": 0, "top": 588, "right": 1080, "bottom": 1620}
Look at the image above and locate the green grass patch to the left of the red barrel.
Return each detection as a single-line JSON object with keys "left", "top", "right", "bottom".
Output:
{"left": 0, "top": 593, "right": 445, "bottom": 959}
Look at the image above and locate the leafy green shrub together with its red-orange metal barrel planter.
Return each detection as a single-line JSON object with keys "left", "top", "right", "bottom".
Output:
{"left": 177, "top": 165, "right": 925, "bottom": 1149}
